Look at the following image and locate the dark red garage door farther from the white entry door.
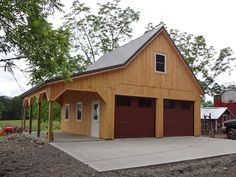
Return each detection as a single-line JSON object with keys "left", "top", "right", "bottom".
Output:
{"left": 164, "top": 100, "right": 194, "bottom": 136}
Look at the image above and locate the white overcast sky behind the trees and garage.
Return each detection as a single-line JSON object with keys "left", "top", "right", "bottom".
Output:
{"left": 0, "top": 0, "right": 236, "bottom": 96}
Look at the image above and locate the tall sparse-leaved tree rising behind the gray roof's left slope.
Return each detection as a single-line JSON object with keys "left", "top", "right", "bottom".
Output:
{"left": 65, "top": 0, "right": 139, "bottom": 70}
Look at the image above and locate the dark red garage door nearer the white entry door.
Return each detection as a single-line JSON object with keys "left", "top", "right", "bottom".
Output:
{"left": 115, "top": 96, "right": 155, "bottom": 138}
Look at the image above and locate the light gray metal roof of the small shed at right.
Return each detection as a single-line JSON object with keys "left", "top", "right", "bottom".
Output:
{"left": 201, "top": 107, "right": 228, "bottom": 119}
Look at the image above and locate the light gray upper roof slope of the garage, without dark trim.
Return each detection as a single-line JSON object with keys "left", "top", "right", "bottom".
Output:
{"left": 87, "top": 26, "right": 162, "bottom": 71}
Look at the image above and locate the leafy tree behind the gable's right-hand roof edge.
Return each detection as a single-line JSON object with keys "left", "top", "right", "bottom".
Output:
{"left": 146, "top": 22, "right": 235, "bottom": 100}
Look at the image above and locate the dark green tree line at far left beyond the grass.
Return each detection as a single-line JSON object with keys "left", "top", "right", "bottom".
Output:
{"left": 0, "top": 96, "right": 22, "bottom": 120}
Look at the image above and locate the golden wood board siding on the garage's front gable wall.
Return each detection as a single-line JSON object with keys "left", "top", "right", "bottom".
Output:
{"left": 23, "top": 31, "right": 203, "bottom": 139}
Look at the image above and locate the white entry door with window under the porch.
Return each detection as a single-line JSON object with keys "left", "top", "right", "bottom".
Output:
{"left": 90, "top": 101, "right": 100, "bottom": 137}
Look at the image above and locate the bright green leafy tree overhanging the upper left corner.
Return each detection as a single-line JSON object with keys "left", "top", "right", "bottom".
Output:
{"left": 0, "top": 0, "right": 70, "bottom": 84}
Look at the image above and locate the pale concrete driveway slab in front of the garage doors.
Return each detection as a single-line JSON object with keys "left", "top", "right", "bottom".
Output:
{"left": 51, "top": 137, "right": 236, "bottom": 172}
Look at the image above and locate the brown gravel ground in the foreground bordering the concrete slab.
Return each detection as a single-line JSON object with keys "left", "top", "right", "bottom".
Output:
{"left": 0, "top": 134, "right": 236, "bottom": 177}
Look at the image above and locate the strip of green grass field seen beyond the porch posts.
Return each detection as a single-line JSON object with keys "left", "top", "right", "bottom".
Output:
{"left": 0, "top": 120, "right": 61, "bottom": 132}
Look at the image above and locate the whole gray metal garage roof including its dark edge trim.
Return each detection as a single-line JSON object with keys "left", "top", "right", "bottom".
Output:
{"left": 21, "top": 26, "right": 204, "bottom": 97}
